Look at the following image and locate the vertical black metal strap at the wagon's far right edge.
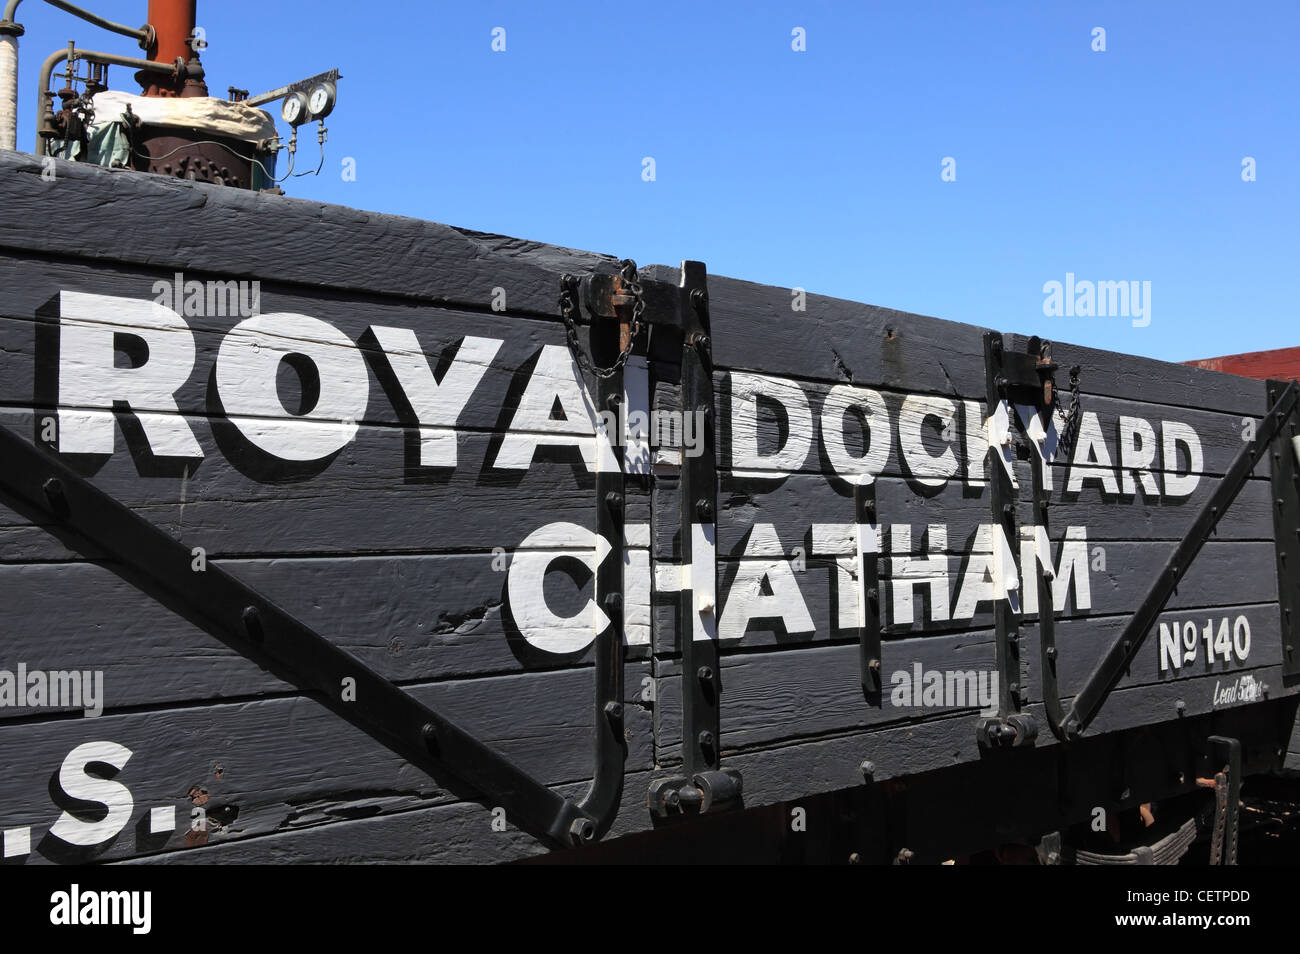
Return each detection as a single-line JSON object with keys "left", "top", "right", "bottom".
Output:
{"left": 1268, "top": 381, "right": 1300, "bottom": 678}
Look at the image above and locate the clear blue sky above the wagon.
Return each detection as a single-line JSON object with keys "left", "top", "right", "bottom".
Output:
{"left": 18, "top": 0, "right": 1300, "bottom": 360}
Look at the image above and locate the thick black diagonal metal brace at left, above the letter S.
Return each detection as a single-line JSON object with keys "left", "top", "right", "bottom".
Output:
{"left": 0, "top": 426, "right": 593, "bottom": 847}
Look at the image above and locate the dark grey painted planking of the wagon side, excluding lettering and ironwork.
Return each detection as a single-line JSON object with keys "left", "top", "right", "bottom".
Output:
{"left": 0, "top": 153, "right": 1300, "bottom": 863}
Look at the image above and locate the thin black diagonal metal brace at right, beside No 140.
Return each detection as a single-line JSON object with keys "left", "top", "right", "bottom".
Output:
{"left": 1058, "top": 381, "right": 1300, "bottom": 740}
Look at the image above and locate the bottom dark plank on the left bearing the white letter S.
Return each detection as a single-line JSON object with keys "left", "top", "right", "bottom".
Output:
{"left": 0, "top": 664, "right": 651, "bottom": 863}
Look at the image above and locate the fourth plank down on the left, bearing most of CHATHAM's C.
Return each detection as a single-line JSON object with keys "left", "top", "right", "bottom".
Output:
{"left": 0, "top": 545, "right": 665, "bottom": 720}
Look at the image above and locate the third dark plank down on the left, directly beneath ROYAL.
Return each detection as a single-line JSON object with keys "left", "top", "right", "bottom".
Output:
{"left": 0, "top": 409, "right": 660, "bottom": 561}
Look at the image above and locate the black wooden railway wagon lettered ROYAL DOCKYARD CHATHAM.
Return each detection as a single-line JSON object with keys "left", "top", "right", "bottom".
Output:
{"left": 0, "top": 153, "right": 1300, "bottom": 864}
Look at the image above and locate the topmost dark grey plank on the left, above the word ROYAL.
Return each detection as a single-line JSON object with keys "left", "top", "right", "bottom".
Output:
{"left": 0, "top": 152, "right": 618, "bottom": 315}
